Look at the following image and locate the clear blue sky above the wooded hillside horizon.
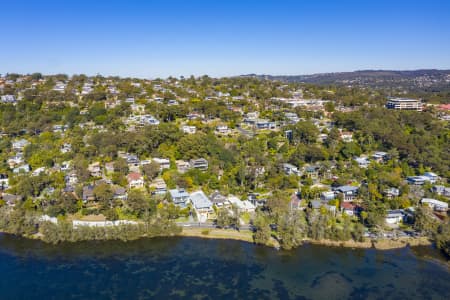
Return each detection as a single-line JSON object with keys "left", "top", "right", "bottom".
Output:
{"left": 0, "top": 0, "right": 450, "bottom": 78}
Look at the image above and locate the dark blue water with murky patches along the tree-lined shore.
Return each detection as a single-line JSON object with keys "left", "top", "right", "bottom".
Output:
{"left": 0, "top": 235, "right": 450, "bottom": 299}
